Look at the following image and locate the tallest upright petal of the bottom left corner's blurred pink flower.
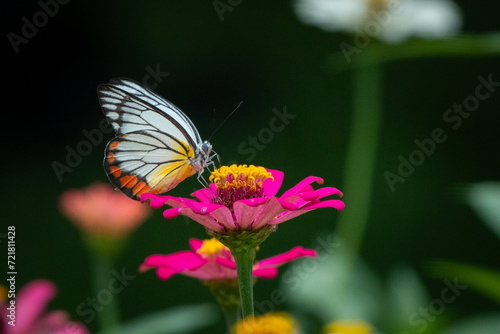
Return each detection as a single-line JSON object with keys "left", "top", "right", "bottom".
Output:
{"left": 16, "top": 280, "right": 56, "bottom": 333}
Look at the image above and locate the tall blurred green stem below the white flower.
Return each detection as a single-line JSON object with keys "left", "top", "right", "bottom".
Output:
{"left": 337, "top": 61, "right": 382, "bottom": 256}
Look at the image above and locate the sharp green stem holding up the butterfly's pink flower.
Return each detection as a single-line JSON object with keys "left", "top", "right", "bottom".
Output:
{"left": 231, "top": 248, "right": 256, "bottom": 318}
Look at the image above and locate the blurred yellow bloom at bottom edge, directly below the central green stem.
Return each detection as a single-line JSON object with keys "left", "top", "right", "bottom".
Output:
{"left": 233, "top": 313, "right": 296, "bottom": 334}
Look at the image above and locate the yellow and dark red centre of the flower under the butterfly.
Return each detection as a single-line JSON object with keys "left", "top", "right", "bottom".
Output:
{"left": 209, "top": 165, "right": 273, "bottom": 209}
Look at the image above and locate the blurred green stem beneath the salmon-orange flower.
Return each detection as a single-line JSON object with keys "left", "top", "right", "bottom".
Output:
{"left": 92, "top": 255, "right": 120, "bottom": 331}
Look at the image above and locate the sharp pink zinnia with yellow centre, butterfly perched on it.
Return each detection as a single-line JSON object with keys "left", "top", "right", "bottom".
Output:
{"left": 141, "top": 165, "right": 344, "bottom": 235}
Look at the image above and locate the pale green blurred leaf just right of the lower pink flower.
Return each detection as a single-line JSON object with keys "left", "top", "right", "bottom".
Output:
{"left": 282, "top": 247, "right": 381, "bottom": 323}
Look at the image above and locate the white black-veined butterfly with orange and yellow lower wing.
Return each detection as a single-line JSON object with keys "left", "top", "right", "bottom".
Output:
{"left": 97, "top": 78, "right": 218, "bottom": 200}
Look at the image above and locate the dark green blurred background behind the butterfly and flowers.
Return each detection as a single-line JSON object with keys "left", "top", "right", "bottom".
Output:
{"left": 0, "top": 0, "right": 500, "bottom": 332}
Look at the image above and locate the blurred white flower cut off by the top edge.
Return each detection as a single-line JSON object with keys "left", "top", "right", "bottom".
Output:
{"left": 295, "top": 0, "right": 462, "bottom": 43}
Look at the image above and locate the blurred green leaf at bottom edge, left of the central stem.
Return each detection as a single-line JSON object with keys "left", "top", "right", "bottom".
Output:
{"left": 100, "top": 304, "right": 219, "bottom": 334}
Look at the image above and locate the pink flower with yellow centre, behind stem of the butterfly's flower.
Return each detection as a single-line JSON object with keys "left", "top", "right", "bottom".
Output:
{"left": 139, "top": 238, "right": 316, "bottom": 281}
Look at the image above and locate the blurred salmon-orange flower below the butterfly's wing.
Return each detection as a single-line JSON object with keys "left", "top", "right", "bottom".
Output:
{"left": 59, "top": 183, "right": 149, "bottom": 238}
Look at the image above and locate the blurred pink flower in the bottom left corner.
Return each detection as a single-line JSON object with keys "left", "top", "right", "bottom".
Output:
{"left": 0, "top": 280, "right": 89, "bottom": 334}
